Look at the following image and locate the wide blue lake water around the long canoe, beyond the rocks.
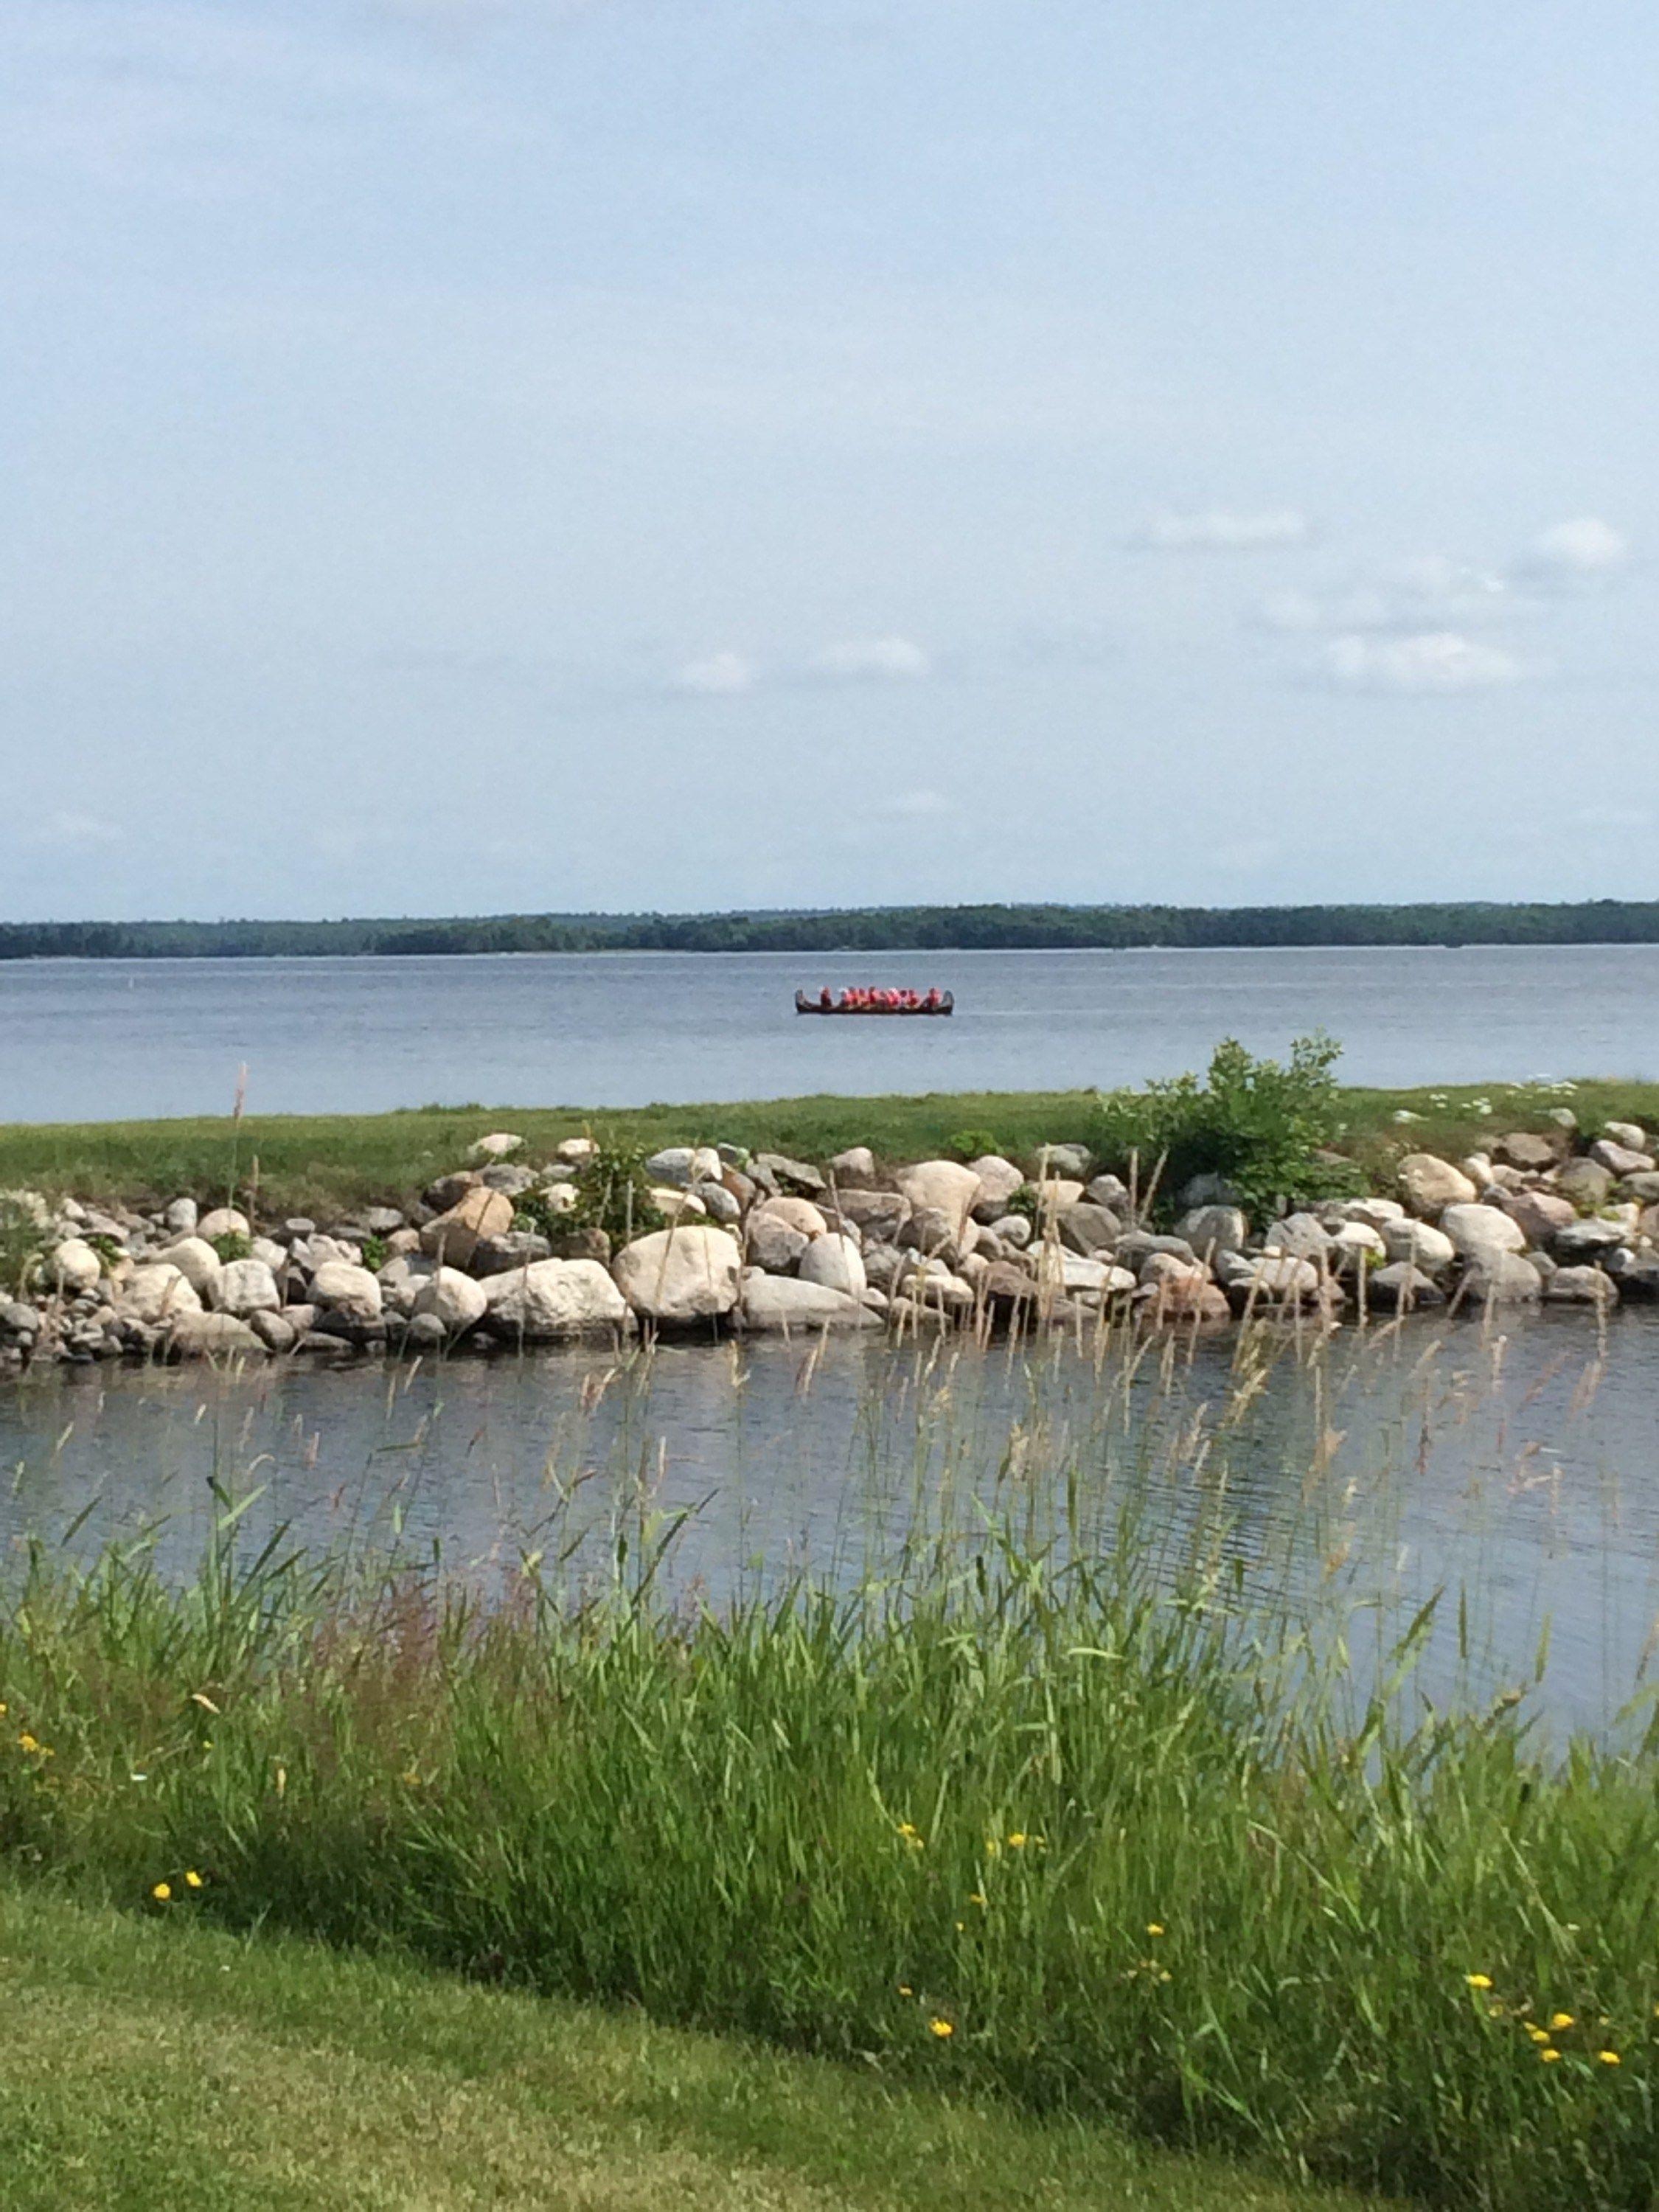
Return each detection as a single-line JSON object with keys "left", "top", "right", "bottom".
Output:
{"left": 0, "top": 945, "right": 1659, "bottom": 1121}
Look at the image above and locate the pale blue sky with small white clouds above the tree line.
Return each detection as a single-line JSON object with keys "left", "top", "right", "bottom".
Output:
{"left": 0, "top": 0, "right": 1659, "bottom": 920}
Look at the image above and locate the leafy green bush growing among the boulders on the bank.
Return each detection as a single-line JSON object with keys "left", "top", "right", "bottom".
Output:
{"left": 1095, "top": 1031, "right": 1358, "bottom": 1217}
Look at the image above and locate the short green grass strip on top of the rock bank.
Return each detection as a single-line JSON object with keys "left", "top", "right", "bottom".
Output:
{"left": 0, "top": 1082, "right": 1659, "bottom": 1214}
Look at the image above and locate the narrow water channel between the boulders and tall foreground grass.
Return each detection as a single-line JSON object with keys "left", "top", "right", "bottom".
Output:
{"left": 0, "top": 1314, "right": 1659, "bottom": 1725}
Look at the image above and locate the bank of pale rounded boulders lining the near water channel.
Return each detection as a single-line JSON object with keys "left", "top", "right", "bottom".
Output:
{"left": 0, "top": 1108, "right": 1659, "bottom": 1374}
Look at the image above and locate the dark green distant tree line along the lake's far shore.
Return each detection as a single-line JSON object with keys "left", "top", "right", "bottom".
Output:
{"left": 0, "top": 898, "right": 1659, "bottom": 960}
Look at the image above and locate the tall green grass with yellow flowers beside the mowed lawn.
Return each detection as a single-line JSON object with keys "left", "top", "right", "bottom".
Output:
{"left": 0, "top": 1524, "right": 1659, "bottom": 2212}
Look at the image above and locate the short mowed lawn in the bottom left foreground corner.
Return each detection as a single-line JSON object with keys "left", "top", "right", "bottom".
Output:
{"left": 0, "top": 1889, "right": 1358, "bottom": 2212}
